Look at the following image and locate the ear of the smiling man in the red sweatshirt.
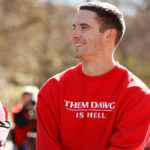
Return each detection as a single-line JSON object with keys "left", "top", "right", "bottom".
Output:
{"left": 105, "top": 29, "right": 117, "bottom": 42}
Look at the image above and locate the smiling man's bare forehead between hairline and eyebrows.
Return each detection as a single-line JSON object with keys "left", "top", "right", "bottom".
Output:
{"left": 74, "top": 10, "right": 97, "bottom": 24}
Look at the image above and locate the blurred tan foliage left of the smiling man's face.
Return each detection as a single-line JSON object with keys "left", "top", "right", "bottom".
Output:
{"left": 0, "top": 0, "right": 76, "bottom": 108}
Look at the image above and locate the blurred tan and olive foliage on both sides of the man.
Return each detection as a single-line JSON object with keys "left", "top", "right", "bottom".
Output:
{"left": 0, "top": 0, "right": 150, "bottom": 108}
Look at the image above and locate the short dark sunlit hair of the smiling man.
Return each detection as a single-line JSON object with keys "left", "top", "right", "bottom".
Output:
{"left": 78, "top": 2, "right": 126, "bottom": 45}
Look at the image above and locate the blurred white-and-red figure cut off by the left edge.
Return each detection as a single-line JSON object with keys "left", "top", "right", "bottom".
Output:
{"left": 0, "top": 102, "right": 10, "bottom": 150}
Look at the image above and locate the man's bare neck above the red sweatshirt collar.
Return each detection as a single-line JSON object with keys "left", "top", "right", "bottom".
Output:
{"left": 82, "top": 54, "right": 115, "bottom": 76}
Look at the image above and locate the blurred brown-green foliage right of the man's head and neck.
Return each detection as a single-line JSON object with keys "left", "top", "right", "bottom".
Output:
{"left": 117, "top": 0, "right": 150, "bottom": 86}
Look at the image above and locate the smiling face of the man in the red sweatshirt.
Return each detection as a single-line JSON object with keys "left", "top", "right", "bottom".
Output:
{"left": 72, "top": 10, "right": 104, "bottom": 61}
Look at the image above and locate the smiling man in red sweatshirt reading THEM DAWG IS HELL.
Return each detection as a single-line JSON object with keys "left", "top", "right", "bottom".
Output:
{"left": 37, "top": 2, "right": 150, "bottom": 150}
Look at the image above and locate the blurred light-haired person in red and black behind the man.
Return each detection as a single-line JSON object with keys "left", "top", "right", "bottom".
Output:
{"left": 12, "top": 86, "right": 39, "bottom": 150}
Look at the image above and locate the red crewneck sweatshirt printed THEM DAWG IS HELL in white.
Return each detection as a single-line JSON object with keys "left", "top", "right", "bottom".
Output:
{"left": 37, "top": 63, "right": 150, "bottom": 150}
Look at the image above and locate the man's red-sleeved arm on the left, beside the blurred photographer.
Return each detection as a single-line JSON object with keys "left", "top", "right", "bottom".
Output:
{"left": 36, "top": 79, "right": 61, "bottom": 150}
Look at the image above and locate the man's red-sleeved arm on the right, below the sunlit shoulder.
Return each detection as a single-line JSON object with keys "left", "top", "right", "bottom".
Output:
{"left": 105, "top": 91, "right": 150, "bottom": 150}
